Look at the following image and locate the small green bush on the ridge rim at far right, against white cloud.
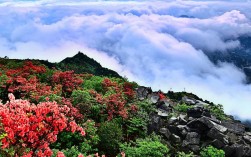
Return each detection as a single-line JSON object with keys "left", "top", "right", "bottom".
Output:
{"left": 208, "top": 104, "right": 228, "bottom": 120}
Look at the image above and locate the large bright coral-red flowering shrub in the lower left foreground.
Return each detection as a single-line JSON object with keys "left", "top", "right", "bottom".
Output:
{"left": 0, "top": 94, "right": 85, "bottom": 157}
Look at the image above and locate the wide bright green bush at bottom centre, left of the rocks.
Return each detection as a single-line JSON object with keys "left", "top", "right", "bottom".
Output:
{"left": 120, "top": 135, "right": 169, "bottom": 157}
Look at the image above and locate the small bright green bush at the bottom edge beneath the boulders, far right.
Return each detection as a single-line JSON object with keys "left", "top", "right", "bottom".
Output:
{"left": 200, "top": 146, "right": 225, "bottom": 157}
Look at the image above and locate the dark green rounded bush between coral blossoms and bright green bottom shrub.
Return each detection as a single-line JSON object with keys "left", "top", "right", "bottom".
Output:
{"left": 98, "top": 121, "right": 123, "bottom": 155}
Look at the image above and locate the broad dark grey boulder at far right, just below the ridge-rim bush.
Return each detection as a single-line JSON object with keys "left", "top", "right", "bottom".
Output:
{"left": 221, "top": 121, "right": 245, "bottom": 135}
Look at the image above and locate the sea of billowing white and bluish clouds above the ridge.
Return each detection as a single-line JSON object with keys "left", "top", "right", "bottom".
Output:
{"left": 0, "top": 0, "right": 251, "bottom": 119}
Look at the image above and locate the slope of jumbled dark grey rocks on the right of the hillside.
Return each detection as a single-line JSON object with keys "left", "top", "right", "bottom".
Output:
{"left": 137, "top": 86, "right": 251, "bottom": 157}
